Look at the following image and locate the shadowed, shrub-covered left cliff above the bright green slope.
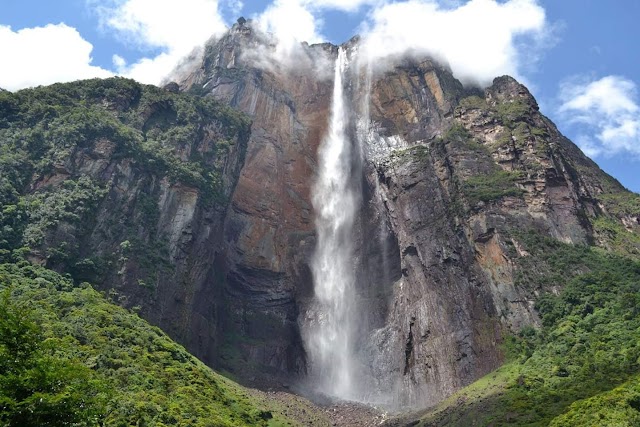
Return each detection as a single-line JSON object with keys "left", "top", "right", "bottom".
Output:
{"left": 0, "top": 79, "right": 249, "bottom": 363}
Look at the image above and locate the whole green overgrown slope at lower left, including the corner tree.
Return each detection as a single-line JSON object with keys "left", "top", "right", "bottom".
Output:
{"left": 0, "top": 261, "right": 298, "bottom": 427}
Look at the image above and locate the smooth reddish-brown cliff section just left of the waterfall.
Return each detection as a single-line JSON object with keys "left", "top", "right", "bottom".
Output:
{"left": 182, "top": 25, "right": 342, "bottom": 380}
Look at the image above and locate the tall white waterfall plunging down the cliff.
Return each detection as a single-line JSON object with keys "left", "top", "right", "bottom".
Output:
{"left": 306, "top": 48, "right": 358, "bottom": 399}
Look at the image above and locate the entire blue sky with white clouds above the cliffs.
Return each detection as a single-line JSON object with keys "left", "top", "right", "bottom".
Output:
{"left": 0, "top": 0, "right": 640, "bottom": 192}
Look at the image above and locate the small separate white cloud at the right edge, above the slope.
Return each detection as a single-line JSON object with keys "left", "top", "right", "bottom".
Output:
{"left": 557, "top": 76, "right": 640, "bottom": 157}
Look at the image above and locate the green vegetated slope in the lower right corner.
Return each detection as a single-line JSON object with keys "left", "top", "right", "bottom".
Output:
{"left": 423, "top": 233, "right": 640, "bottom": 426}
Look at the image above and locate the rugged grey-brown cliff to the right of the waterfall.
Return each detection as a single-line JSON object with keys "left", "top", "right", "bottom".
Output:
{"left": 356, "top": 71, "right": 609, "bottom": 405}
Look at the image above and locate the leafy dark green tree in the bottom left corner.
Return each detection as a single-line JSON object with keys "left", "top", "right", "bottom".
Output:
{"left": 0, "top": 289, "right": 106, "bottom": 427}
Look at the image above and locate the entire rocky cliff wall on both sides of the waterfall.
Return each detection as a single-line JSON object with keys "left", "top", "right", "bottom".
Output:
{"left": 0, "top": 20, "right": 640, "bottom": 414}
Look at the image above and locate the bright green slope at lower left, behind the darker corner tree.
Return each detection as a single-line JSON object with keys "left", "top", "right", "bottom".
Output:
{"left": 0, "top": 262, "right": 324, "bottom": 426}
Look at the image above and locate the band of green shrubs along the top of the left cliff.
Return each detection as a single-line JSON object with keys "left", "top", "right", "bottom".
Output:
{"left": 0, "top": 78, "right": 248, "bottom": 211}
